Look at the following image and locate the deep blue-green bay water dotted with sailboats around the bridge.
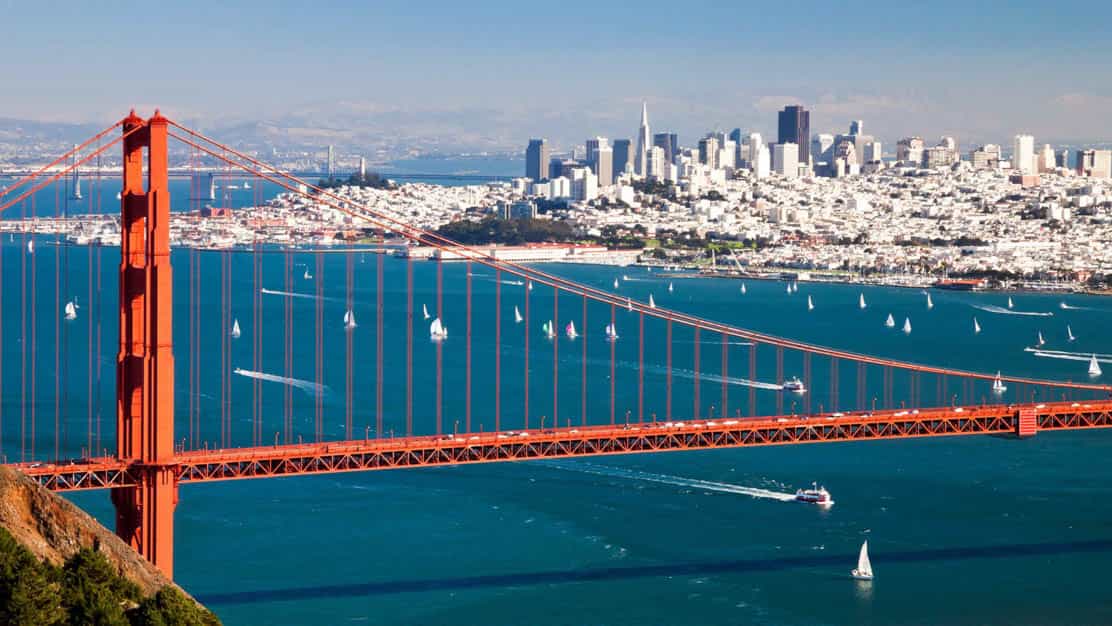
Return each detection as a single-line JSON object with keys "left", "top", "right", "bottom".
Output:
{"left": 0, "top": 176, "right": 1112, "bottom": 624}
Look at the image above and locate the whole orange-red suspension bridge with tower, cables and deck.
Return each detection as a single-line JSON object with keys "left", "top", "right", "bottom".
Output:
{"left": 0, "top": 111, "right": 1112, "bottom": 575}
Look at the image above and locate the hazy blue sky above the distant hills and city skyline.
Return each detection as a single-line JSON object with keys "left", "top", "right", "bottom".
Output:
{"left": 0, "top": 0, "right": 1112, "bottom": 143}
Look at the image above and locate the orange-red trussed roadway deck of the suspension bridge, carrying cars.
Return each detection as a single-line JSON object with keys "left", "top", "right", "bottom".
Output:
{"left": 12, "top": 400, "right": 1112, "bottom": 491}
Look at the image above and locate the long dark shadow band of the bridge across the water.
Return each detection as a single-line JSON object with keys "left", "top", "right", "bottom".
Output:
{"left": 197, "top": 539, "right": 1112, "bottom": 606}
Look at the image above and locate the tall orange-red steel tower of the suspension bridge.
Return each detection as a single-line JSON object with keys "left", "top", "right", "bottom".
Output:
{"left": 112, "top": 111, "right": 178, "bottom": 578}
